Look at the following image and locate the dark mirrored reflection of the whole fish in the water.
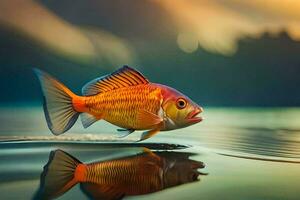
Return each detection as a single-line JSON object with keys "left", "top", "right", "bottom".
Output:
{"left": 35, "top": 149, "right": 206, "bottom": 199}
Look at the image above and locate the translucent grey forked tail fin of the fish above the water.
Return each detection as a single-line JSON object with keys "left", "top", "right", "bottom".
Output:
{"left": 34, "top": 69, "right": 80, "bottom": 135}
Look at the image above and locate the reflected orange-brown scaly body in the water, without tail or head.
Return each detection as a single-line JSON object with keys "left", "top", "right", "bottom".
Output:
{"left": 81, "top": 153, "right": 164, "bottom": 195}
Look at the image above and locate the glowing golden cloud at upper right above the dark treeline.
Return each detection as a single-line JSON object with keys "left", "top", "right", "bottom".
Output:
{"left": 153, "top": 0, "right": 300, "bottom": 55}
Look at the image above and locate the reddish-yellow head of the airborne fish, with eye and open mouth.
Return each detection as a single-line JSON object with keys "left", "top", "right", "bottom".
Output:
{"left": 162, "top": 86, "right": 203, "bottom": 130}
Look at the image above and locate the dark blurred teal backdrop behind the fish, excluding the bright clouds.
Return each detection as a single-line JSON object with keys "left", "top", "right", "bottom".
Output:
{"left": 0, "top": 1, "right": 300, "bottom": 106}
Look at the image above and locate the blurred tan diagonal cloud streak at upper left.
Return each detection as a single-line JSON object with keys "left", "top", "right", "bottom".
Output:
{"left": 0, "top": 0, "right": 135, "bottom": 65}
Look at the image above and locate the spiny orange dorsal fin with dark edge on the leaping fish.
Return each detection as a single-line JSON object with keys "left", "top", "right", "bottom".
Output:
{"left": 82, "top": 65, "right": 149, "bottom": 96}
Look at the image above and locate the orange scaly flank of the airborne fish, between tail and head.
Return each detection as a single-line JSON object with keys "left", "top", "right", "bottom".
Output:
{"left": 86, "top": 84, "right": 162, "bottom": 130}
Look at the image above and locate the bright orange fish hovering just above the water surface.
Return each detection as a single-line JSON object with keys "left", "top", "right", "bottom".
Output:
{"left": 34, "top": 65, "right": 203, "bottom": 141}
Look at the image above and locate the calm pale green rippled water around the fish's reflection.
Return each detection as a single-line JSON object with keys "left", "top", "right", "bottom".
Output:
{"left": 0, "top": 106, "right": 300, "bottom": 199}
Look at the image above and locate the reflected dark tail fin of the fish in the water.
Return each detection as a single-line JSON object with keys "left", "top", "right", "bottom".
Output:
{"left": 34, "top": 150, "right": 81, "bottom": 199}
